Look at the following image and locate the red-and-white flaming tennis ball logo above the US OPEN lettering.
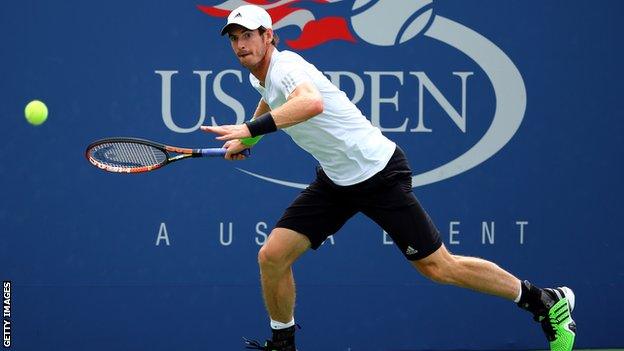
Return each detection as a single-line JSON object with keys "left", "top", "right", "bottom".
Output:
{"left": 198, "top": 0, "right": 433, "bottom": 50}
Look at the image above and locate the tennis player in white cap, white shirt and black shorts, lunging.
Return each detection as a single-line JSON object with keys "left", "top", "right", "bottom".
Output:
{"left": 202, "top": 5, "right": 576, "bottom": 351}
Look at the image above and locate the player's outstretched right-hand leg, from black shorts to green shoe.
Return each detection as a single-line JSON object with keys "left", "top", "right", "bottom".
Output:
{"left": 357, "top": 148, "right": 576, "bottom": 351}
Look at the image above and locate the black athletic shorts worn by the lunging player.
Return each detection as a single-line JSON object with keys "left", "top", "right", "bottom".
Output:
{"left": 275, "top": 146, "right": 442, "bottom": 260}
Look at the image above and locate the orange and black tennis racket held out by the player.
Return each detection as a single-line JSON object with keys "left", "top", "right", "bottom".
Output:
{"left": 85, "top": 138, "right": 250, "bottom": 173}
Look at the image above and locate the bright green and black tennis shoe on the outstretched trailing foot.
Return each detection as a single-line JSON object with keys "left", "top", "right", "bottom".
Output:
{"left": 536, "top": 287, "right": 576, "bottom": 351}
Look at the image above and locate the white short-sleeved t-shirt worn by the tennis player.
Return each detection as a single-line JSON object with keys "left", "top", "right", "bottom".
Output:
{"left": 249, "top": 49, "right": 396, "bottom": 186}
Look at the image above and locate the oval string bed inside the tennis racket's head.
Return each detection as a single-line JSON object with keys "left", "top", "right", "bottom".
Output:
{"left": 91, "top": 142, "right": 167, "bottom": 168}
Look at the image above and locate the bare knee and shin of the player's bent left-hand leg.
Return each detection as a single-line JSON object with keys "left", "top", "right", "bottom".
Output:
{"left": 258, "top": 228, "right": 310, "bottom": 324}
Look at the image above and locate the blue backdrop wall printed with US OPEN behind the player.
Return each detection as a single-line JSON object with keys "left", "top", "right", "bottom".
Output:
{"left": 0, "top": 0, "right": 624, "bottom": 351}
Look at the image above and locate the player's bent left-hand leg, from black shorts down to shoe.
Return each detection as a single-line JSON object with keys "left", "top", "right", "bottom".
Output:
{"left": 248, "top": 168, "right": 357, "bottom": 351}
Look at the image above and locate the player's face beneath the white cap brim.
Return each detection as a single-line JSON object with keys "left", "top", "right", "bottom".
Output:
{"left": 228, "top": 26, "right": 271, "bottom": 70}
